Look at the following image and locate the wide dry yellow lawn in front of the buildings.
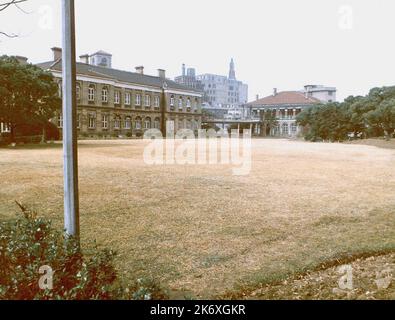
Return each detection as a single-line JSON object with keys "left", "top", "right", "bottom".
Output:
{"left": 0, "top": 139, "right": 395, "bottom": 298}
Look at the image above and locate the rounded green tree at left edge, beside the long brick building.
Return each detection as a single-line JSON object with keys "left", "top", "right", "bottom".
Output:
{"left": 0, "top": 56, "right": 61, "bottom": 141}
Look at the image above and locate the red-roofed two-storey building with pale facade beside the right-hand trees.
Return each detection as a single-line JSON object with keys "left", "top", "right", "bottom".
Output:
{"left": 246, "top": 86, "right": 336, "bottom": 137}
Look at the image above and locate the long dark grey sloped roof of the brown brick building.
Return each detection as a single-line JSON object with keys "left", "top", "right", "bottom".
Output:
{"left": 37, "top": 60, "right": 201, "bottom": 93}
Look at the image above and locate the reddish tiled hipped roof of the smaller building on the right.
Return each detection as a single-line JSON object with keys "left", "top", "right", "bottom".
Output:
{"left": 248, "top": 91, "right": 320, "bottom": 106}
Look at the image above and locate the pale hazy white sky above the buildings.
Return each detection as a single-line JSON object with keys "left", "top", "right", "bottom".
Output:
{"left": 0, "top": 0, "right": 395, "bottom": 100}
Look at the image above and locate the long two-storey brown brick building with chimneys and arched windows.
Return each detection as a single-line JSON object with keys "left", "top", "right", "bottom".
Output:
{"left": 38, "top": 48, "right": 202, "bottom": 137}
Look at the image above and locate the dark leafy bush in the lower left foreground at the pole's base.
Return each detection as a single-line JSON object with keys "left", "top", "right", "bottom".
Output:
{"left": 0, "top": 205, "right": 166, "bottom": 300}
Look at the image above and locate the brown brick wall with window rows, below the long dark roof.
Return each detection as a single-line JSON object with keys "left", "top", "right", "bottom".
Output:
{"left": 52, "top": 74, "right": 202, "bottom": 137}
